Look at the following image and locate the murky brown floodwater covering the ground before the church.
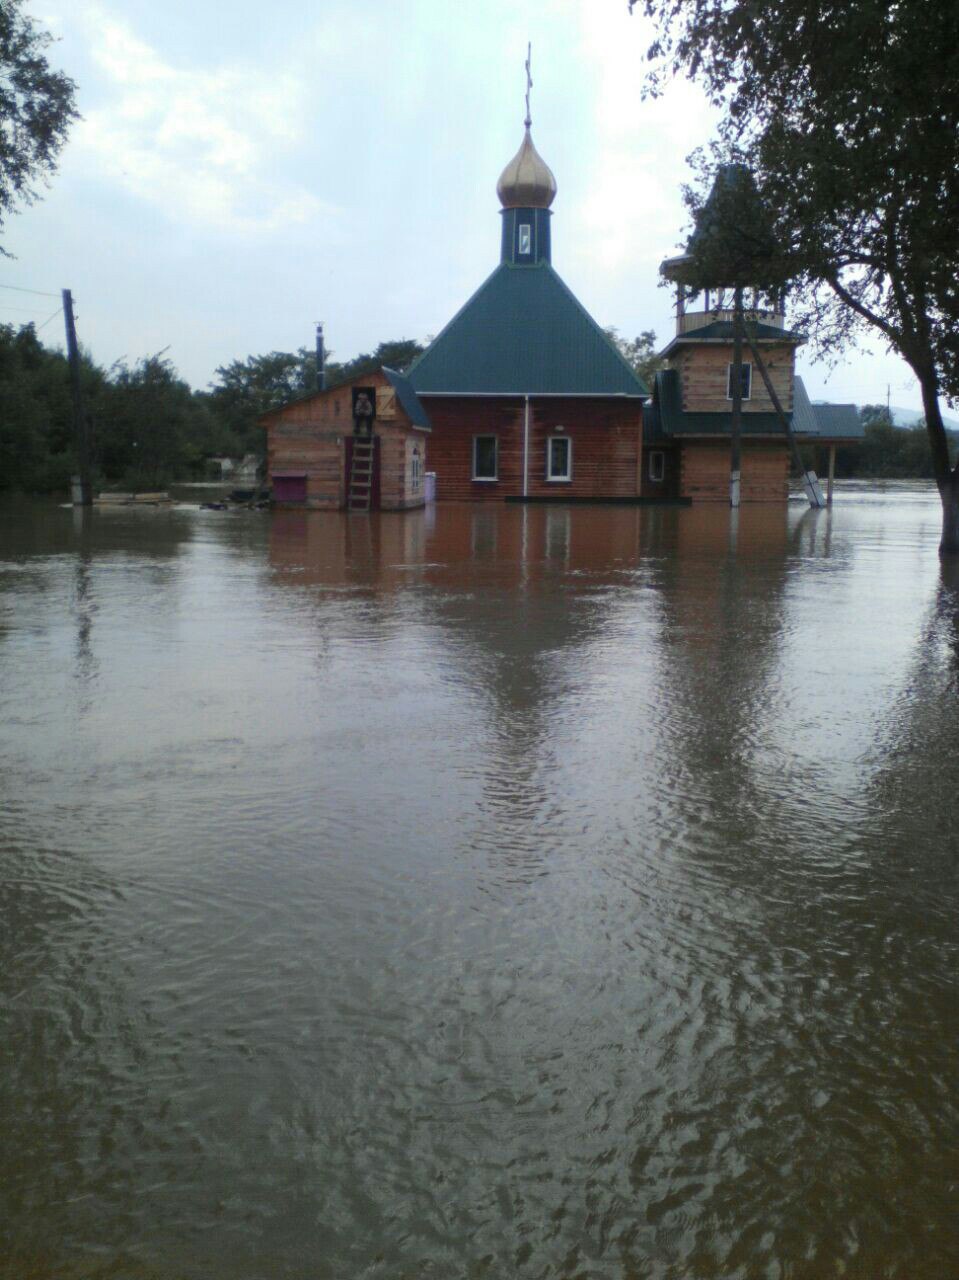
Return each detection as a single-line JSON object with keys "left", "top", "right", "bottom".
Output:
{"left": 0, "top": 489, "right": 959, "bottom": 1280}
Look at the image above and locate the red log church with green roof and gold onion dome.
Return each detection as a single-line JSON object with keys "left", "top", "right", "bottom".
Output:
{"left": 399, "top": 122, "right": 649, "bottom": 502}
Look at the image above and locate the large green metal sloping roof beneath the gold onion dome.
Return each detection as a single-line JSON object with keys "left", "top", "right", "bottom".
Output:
{"left": 407, "top": 262, "right": 649, "bottom": 397}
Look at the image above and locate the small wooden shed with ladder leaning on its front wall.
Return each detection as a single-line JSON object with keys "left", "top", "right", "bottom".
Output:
{"left": 260, "top": 369, "right": 430, "bottom": 511}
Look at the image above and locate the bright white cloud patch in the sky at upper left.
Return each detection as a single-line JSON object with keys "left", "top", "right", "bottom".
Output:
{"left": 73, "top": 5, "right": 335, "bottom": 237}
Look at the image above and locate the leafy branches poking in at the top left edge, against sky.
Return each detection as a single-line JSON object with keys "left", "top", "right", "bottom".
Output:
{"left": 0, "top": 0, "right": 78, "bottom": 256}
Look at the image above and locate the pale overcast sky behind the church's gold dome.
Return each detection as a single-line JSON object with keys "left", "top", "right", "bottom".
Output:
{"left": 0, "top": 0, "right": 921, "bottom": 408}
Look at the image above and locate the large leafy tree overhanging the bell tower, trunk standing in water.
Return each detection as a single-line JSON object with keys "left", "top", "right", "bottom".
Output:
{"left": 630, "top": 0, "right": 959, "bottom": 554}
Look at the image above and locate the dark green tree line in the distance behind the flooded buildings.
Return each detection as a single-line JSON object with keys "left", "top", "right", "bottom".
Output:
{"left": 0, "top": 325, "right": 955, "bottom": 494}
